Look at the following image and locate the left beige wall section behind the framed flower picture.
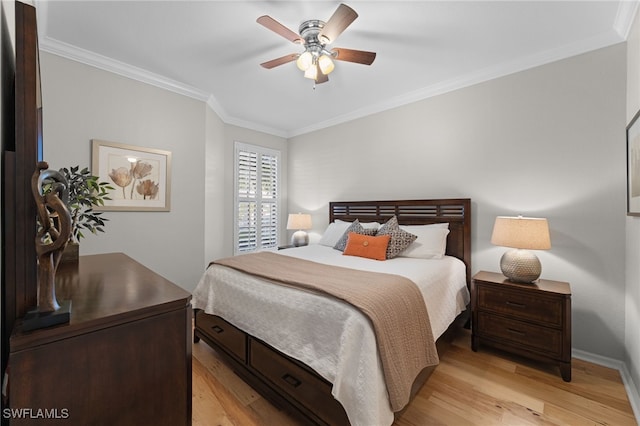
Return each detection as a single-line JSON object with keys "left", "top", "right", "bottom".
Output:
{"left": 40, "top": 52, "right": 207, "bottom": 290}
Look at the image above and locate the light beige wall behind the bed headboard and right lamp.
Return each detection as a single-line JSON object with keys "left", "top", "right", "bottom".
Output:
{"left": 289, "top": 44, "right": 625, "bottom": 360}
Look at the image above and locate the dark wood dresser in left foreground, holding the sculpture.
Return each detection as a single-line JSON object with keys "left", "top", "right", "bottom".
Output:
{"left": 9, "top": 253, "right": 193, "bottom": 425}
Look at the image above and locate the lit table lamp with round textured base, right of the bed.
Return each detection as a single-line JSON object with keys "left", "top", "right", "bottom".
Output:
{"left": 491, "top": 216, "right": 551, "bottom": 283}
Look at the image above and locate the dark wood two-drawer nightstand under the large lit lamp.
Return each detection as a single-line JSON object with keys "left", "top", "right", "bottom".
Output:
{"left": 471, "top": 271, "right": 571, "bottom": 382}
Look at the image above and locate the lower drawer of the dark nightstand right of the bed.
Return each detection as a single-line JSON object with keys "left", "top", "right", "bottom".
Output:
{"left": 477, "top": 312, "right": 562, "bottom": 359}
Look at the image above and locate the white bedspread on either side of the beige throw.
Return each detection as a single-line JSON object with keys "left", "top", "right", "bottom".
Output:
{"left": 192, "top": 245, "right": 469, "bottom": 426}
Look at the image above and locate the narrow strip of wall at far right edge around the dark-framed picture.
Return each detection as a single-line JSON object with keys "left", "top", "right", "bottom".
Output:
{"left": 625, "top": 5, "right": 640, "bottom": 416}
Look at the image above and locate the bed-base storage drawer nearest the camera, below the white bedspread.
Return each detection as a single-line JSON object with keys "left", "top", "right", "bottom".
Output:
{"left": 249, "top": 339, "right": 344, "bottom": 424}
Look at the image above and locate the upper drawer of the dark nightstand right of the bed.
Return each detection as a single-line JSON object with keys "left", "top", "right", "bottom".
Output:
{"left": 477, "top": 285, "right": 564, "bottom": 328}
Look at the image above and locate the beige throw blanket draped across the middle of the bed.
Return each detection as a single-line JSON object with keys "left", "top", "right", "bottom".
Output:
{"left": 212, "top": 252, "right": 439, "bottom": 411}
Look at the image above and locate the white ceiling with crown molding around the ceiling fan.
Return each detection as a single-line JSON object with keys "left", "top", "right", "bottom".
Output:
{"left": 35, "top": 0, "right": 637, "bottom": 137}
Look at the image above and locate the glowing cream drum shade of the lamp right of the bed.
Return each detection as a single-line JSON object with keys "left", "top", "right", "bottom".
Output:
{"left": 491, "top": 216, "right": 551, "bottom": 250}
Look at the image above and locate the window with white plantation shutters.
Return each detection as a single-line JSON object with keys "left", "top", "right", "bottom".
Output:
{"left": 234, "top": 142, "right": 280, "bottom": 253}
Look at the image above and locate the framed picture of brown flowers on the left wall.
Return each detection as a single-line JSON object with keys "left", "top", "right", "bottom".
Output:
{"left": 91, "top": 139, "right": 171, "bottom": 212}
